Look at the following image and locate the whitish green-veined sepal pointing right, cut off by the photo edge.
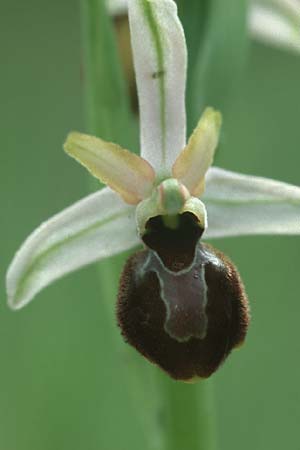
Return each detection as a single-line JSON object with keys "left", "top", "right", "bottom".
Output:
{"left": 202, "top": 167, "right": 300, "bottom": 239}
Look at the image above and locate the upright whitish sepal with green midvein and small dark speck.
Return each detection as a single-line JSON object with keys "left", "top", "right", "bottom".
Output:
{"left": 128, "top": 0, "right": 187, "bottom": 172}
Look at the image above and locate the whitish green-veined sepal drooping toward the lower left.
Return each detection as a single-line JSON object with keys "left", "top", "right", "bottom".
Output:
{"left": 6, "top": 188, "right": 139, "bottom": 309}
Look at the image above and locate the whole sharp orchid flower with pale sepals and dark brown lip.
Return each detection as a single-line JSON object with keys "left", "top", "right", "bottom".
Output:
{"left": 7, "top": 0, "right": 300, "bottom": 380}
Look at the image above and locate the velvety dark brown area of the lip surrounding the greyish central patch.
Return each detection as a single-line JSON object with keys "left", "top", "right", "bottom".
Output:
{"left": 117, "top": 244, "right": 249, "bottom": 380}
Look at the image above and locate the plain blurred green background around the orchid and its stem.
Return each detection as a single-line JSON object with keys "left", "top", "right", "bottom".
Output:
{"left": 0, "top": 0, "right": 300, "bottom": 450}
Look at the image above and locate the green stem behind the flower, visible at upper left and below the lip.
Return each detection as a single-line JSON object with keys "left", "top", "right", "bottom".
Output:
{"left": 81, "top": 0, "right": 215, "bottom": 450}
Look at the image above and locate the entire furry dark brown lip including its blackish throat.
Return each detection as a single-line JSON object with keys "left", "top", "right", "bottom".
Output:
{"left": 117, "top": 213, "right": 249, "bottom": 381}
